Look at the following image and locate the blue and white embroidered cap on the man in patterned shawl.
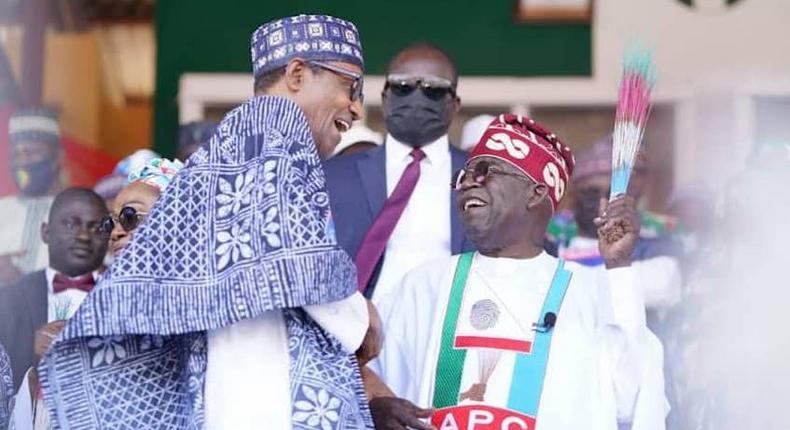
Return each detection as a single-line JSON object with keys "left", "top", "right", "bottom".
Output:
{"left": 250, "top": 15, "right": 365, "bottom": 79}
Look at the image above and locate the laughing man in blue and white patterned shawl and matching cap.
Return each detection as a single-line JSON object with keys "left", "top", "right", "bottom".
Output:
{"left": 39, "top": 15, "right": 377, "bottom": 429}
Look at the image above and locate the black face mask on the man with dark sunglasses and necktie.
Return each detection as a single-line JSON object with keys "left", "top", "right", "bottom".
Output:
{"left": 386, "top": 90, "right": 452, "bottom": 148}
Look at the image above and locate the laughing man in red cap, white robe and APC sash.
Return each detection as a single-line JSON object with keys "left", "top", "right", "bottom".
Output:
{"left": 371, "top": 115, "right": 665, "bottom": 430}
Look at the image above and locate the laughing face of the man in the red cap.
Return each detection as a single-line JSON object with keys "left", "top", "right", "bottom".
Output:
{"left": 456, "top": 156, "right": 551, "bottom": 251}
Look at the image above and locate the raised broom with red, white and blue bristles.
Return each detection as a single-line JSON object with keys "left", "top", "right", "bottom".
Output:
{"left": 607, "top": 46, "right": 656, "bottom": 242}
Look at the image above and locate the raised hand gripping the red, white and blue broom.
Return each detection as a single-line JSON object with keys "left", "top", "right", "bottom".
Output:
{"left": 594, "top": 195, "right": 641, "bottom": 269}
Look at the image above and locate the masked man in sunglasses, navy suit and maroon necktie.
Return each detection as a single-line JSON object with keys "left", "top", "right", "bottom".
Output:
{"left": 325, "top": 43, "right": 472, "bottom": 302}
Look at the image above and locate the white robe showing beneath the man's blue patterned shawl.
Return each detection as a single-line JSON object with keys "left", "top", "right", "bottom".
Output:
{"left": 205, "top": 293, "right": 369, "bottom": 430}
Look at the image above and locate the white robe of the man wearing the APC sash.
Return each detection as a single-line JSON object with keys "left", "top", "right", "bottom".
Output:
{"left": 372, "top": 253, "right": 666, "bottom": 430}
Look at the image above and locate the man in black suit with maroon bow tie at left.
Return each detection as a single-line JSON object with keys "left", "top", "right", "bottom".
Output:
{"left": 0, "top": 188, "right": 109, "bottom": 391}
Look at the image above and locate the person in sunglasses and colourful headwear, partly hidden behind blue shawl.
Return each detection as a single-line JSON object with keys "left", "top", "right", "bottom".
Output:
{"left": 102, "top": 158, "right": 184, "bottom": 257}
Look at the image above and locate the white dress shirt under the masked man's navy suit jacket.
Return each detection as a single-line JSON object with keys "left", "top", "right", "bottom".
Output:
{"left": 373, "top": 135, "right": 452, "bottom": 303}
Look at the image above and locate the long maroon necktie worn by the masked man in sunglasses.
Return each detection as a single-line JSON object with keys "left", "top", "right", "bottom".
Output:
{"left": 354, "top": 148, "right": 425, "bottom": 293}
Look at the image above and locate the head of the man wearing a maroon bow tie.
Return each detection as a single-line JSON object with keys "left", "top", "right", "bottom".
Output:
{"left": 41, "top": 190, "right": 107, "bottom": 276}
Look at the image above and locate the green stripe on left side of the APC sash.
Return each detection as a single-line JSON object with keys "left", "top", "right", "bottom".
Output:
{"left": 433, "top": 252, "right": 474, "bottom": 409}
